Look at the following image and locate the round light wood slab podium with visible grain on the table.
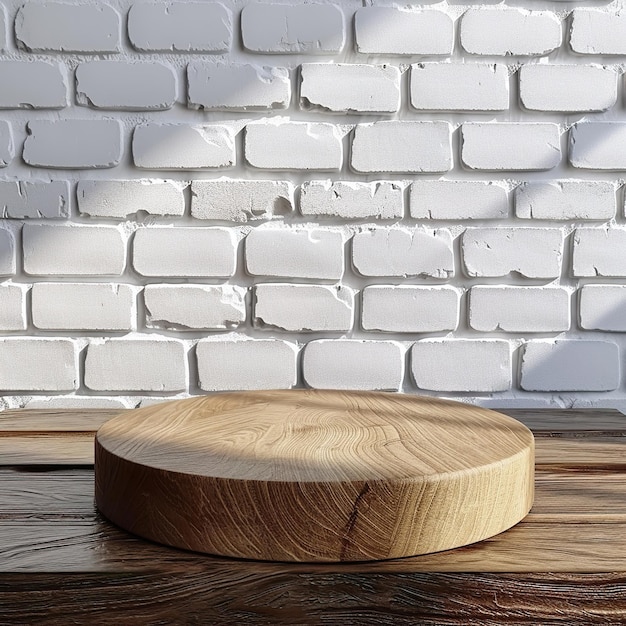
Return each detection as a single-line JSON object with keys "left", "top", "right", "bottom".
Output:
{"left": 95, "top": 390, "right": 534, "bottom": 561}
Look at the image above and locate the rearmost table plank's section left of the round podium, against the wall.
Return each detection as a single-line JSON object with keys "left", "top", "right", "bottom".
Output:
{"left": 0, "top": 409, "right": 121, "bottom": 437}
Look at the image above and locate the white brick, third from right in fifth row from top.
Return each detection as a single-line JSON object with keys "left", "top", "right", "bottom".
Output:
{"left": 352, "top": 227, "right": 454, "bottom": 278}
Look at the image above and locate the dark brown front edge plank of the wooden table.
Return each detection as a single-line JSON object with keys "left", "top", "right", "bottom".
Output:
{"left": 0, "top": 569, "right": 626, "bottom": 626}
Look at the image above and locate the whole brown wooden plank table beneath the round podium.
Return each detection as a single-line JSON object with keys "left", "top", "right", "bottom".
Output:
{"left": 0, "top": 410, "right": 626, "bottom": 626}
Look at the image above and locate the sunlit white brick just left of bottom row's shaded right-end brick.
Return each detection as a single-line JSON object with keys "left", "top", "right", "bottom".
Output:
{"left": 411, "top": 339, "right": 512, "bottom": 393}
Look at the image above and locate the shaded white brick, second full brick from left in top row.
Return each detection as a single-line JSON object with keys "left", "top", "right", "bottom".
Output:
{"left": 128, "top": 2, "right": 233, "bottom": 53}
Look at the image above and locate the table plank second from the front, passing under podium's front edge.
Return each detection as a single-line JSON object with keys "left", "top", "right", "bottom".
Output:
{"left": 0, "top": 515, "right": 626, "bottom": 575}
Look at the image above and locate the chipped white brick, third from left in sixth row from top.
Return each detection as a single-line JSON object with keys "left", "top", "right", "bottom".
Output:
{"left": 143, "top": 285, "right": 246, "bottom": 330}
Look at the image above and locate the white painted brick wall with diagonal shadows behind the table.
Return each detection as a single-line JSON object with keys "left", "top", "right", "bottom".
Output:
{"left": 0, "top": 0, "right": 626, "bottom": 410}
